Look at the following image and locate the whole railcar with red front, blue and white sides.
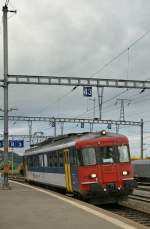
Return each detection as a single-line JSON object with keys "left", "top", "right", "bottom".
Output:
{"left": 24, "top": 130, "right": 136, "bottom": 204}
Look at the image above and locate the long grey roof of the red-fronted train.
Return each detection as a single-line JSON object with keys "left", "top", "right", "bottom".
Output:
{"left": 24, "top": 130, "right": 125, "bottom": 155}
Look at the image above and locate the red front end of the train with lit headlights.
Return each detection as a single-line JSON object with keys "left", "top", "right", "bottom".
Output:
{"left": 76, "top": 132, "right": 136, "bottom": 204}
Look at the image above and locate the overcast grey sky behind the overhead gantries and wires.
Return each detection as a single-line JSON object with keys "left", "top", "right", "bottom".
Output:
{"left": 0, "top": 0, "right": 150, "bottom": 155}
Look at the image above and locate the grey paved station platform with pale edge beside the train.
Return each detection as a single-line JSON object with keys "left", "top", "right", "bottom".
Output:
{"left": 0, "top": 182, "right": 146, "bottom": 229}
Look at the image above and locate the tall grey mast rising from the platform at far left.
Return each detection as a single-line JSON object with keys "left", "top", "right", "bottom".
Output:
{"left": 2, "top": 5, "right": 9, "bottom": 188}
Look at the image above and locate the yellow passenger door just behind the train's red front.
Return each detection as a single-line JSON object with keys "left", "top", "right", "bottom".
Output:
{"left": 64, "top": 149, "right": 73, "bottom": 192}
